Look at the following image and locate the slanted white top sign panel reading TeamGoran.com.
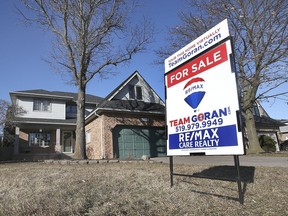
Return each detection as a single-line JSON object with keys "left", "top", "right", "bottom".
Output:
{"left": 165, "top": 19, "right": 229, "bottom": 72}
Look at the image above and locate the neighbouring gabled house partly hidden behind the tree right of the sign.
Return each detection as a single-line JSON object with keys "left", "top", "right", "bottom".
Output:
{"left": 253, "top": 102, "right": 285, "bottom": 151}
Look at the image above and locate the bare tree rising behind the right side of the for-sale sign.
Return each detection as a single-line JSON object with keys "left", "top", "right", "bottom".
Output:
{"left": 158, "top": 0, "right": 288, "bottom": 153}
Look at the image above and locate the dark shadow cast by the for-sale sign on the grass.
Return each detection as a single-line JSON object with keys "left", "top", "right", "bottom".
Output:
{"left": 176, "top": 166, "right": 255, "bottom": 204}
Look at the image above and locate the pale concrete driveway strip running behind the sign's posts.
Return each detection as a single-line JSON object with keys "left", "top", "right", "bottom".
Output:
{"left": 151, "top": 155, "right": 288, "bottom": 168}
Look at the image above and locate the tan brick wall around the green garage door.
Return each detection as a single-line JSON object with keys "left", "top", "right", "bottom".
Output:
{"left": 85, "top": 113, "right": 165, "bottom": 159}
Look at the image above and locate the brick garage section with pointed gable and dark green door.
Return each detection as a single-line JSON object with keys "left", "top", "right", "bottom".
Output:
{"left": 85, "top": 71, "right": 166, "bottom": 159}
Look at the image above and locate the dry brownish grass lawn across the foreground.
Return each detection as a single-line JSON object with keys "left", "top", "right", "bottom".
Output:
{"left": 0, "top": 163, "right": 288, "bottom": 216}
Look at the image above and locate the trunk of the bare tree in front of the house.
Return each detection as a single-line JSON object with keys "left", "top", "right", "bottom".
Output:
{"left": 74, "top": 85, "right": 87, "bottom": 160}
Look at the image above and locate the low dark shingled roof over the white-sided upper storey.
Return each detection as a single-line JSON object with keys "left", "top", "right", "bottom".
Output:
{"left": 10, "top": 89, "right": 103, "bottom": 104}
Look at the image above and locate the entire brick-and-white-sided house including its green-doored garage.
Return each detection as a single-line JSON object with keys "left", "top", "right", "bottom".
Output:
{"left": 10, "top": 71, "right": 166, "bottom": 159}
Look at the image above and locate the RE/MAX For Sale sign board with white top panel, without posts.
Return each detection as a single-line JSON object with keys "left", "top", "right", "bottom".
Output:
{"left": 165, "top": 20, "right": 244, "bottom": 156}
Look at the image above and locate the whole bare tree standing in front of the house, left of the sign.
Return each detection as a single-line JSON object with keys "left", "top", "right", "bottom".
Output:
{"left": 19, "top": 0, "right": 153, "bottom": 159}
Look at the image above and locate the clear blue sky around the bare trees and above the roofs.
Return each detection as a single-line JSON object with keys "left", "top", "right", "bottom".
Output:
{"left": 0, "top": 0, "right": 288, "bottom": 119}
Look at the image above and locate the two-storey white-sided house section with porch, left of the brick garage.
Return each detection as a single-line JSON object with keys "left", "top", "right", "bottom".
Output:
{"left": 10, "top": 89, "right": 103, "bottom": 158}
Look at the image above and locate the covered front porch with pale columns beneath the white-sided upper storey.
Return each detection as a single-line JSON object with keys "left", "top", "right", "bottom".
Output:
{"left": 13, "top": 125, "right": 75, "bottom": 157}
